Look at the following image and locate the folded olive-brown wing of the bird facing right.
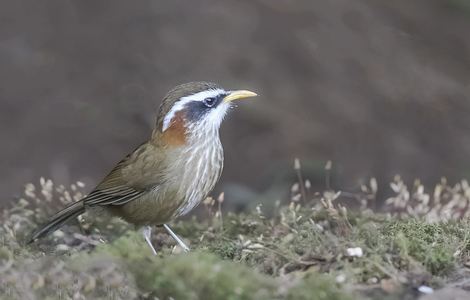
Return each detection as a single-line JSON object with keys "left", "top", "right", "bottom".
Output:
{"left": 83, "top": 143, "right": 164, "bottom": 206}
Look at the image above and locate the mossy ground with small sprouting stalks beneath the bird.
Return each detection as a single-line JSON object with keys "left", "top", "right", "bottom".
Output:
{"left": 0, "top": 177, "right": 470, "bottom": 299}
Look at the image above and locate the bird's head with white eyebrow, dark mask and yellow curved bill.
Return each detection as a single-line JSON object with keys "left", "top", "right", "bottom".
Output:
{"left": 155, "top": 82, "right": 257, "bottom": 145}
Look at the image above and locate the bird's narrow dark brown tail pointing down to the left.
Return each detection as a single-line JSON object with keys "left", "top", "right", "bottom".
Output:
{"left": 28, "top": 201, "right": 85, "bottom": 244}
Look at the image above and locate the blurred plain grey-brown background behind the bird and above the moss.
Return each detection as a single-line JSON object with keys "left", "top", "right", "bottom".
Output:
{"left": 0, "top": 0, "right": 470, "bottom": 205}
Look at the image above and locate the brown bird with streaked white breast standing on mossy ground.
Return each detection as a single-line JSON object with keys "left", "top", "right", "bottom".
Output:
{"left": 28, "top": 82, "right": 257, "bottom": 255}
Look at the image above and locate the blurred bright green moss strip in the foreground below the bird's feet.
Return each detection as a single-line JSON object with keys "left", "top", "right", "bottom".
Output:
{"left": 89, "top": 234, "right": 348, "bottom": 300}
